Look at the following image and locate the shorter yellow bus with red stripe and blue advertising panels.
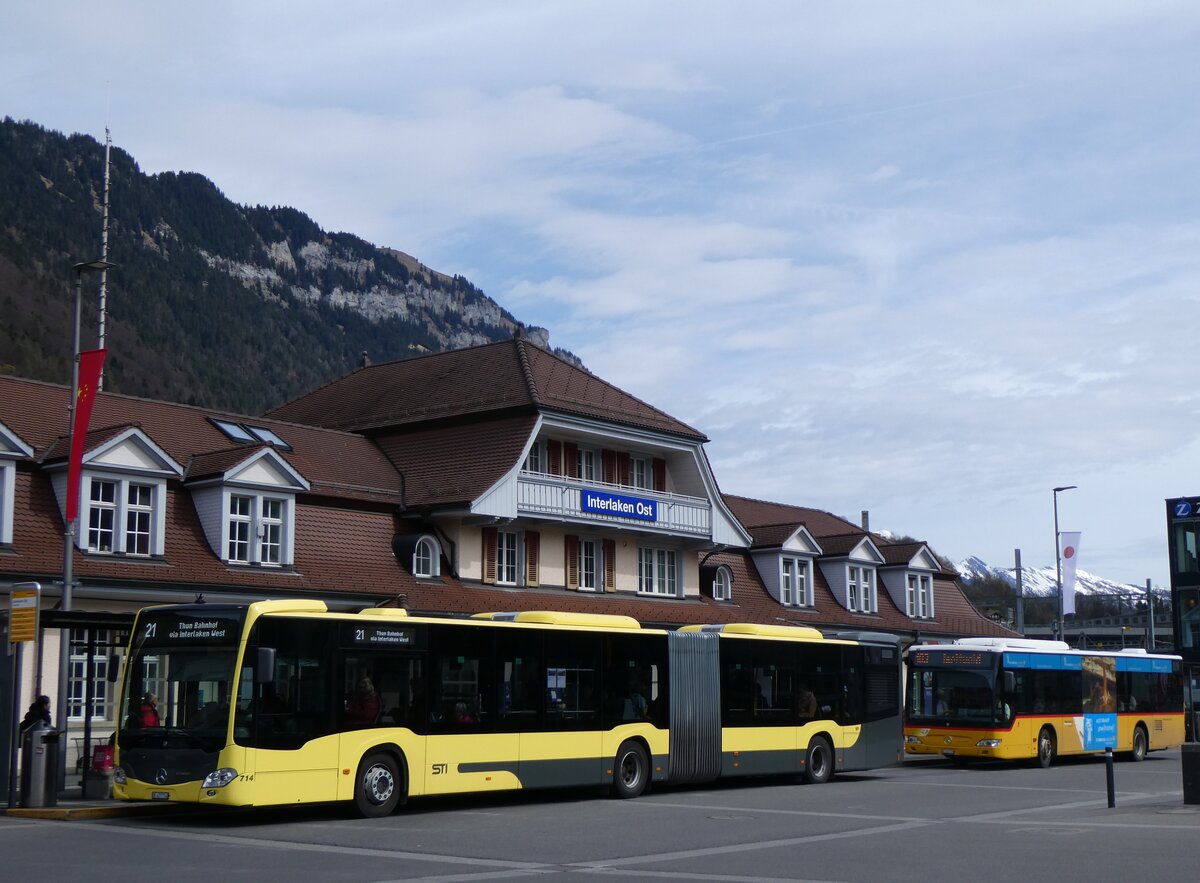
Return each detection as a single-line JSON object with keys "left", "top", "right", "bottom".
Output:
{"left": 904, "top": 638, "right": 1183, "bottom": 767}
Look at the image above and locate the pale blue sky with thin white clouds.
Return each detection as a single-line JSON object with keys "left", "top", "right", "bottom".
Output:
{"left": 0, "top": 0, "right": 1200, "bottom": 585}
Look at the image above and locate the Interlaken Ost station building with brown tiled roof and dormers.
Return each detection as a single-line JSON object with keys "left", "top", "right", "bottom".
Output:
{"left": 0, "top": 338, "right": 1012, "bottom": 772}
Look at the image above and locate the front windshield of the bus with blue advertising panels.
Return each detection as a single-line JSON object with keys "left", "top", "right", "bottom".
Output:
{"left": 907, "top": 649, "right": 1007, "bottom": 726}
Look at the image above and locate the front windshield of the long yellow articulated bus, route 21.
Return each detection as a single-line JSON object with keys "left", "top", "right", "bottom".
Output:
{"left": 118, "top": 605, "right": 245, "bottom": 785}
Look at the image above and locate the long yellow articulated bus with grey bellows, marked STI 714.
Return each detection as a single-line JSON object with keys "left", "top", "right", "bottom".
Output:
{"left": 113, "top": 601, "right": 901, "bottom": 817}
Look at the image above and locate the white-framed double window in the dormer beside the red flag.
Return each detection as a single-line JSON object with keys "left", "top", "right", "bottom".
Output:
{"left": 79, "top": 471, "right": 166, "bottom": 558}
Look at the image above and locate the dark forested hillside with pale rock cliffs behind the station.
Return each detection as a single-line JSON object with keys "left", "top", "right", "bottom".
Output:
{"left": 0, "top": 118, "right": 569, "bottom": 413}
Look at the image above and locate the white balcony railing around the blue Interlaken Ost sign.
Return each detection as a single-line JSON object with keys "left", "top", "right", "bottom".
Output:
{"left": 517, "top": 471, "right": 713, "bottom": 536}
